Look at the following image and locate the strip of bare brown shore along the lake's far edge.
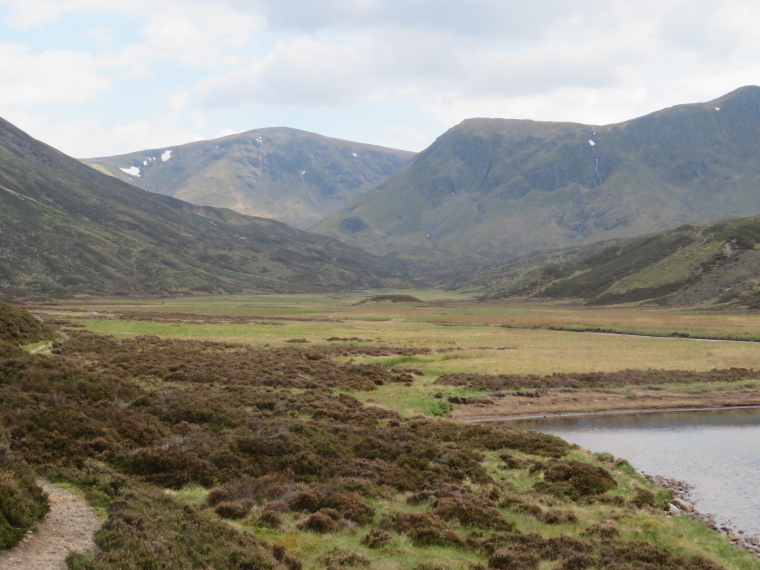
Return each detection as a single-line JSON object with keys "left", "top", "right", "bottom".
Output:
{"left": 452, "top": 388, "right": 760, "bottom": 422}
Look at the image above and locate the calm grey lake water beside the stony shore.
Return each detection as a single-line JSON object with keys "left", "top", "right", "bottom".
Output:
{"left": 519, "top": 409, "right": 760, "bottom": 536}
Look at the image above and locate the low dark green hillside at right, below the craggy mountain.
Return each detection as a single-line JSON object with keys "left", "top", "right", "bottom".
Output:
{"left": 454, "top": 216, "right": 760, "bottom": 308}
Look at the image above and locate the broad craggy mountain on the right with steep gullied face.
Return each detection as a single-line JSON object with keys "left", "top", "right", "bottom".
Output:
{"left": 311, "top": 87, "right": 760, "bottom": 260}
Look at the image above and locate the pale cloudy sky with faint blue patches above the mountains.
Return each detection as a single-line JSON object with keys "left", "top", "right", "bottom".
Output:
{"left": 0, "top": 0, "right": 760, "bottom": 158}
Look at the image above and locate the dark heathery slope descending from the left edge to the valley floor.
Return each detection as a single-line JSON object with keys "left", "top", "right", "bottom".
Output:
{"left": 0, "top": 119, "right": 416, "bottom": 297}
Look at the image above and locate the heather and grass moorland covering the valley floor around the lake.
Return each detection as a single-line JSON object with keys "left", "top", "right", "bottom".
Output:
{"left": 0, "top": 296, "right": 760, "bottom": 570}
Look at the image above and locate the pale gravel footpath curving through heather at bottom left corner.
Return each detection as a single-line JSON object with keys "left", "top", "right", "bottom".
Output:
{"left": 0, "top": 479, "right": 101, "bottom": 570}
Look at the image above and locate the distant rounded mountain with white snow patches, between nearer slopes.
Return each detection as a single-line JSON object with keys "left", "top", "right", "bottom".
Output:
{"left": 84, "top": 127, "right": 414, "bottom": 229}
